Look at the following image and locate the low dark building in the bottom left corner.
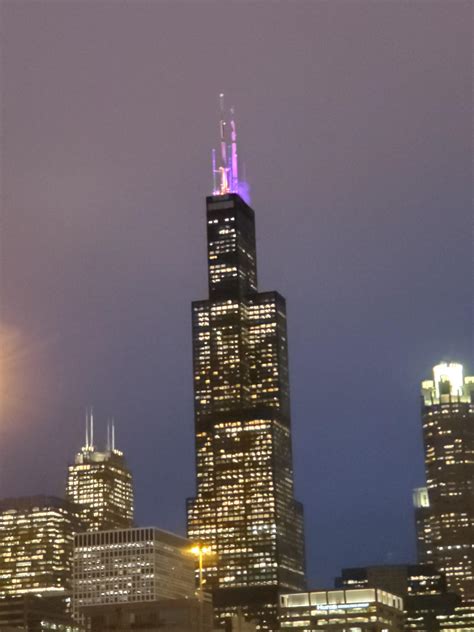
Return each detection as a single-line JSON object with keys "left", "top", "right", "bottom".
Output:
{"left": 0, "top": 595, "right": 82, "bottom": 632}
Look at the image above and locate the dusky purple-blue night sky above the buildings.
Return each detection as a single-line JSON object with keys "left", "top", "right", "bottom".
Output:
{"left": 0, "top": 0, "right": 474, "bottom": 587}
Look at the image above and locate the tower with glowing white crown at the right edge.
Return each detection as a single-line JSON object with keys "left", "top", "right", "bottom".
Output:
{"left": 416, "top": 363, "right": 474, "bottom": 601}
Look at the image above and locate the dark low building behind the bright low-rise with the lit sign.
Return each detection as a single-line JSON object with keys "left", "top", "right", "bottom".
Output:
{"left": 336, "top": 564, "right": 461, "bottom": 632}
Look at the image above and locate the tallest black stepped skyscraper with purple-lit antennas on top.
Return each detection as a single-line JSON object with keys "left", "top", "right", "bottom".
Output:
{"left": 187, "top": 96, "right": 305, "bottom": 630}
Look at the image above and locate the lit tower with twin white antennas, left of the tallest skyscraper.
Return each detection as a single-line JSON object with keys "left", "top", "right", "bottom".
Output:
{"left": 66, "top": 411, "right": 133, "bottom": 531}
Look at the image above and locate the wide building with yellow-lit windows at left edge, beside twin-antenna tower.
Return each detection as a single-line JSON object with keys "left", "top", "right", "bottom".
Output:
{"left": 0, "top": 496, "right": 80, "bottom": 598}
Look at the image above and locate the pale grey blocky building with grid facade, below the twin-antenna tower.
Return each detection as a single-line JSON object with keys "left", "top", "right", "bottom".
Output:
{"left": 73, "top": 528, "right": 195, "bottom": 617}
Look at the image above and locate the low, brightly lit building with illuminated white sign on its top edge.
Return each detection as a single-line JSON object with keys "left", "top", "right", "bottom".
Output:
{"left": 280, "top": 588, "right": 404, "bottom": 632}
